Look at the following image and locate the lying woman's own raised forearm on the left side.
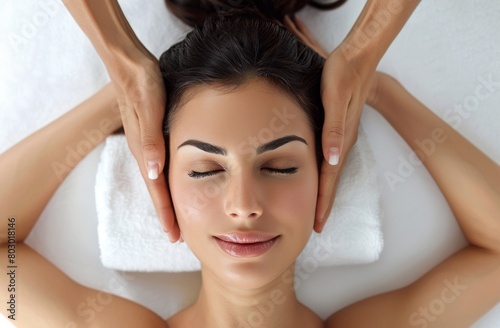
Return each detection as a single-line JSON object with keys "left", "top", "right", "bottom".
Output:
{"left": 0, "top": 85, "right": 121, "bottom": 242}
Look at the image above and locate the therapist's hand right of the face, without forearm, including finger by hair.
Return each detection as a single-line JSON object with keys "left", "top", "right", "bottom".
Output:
{"left": 284, "top": 16, "right": 373, "bottom": 232}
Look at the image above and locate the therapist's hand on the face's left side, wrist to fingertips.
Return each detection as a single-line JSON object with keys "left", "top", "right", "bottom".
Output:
{"left": 111, "top": 53, "right": 180, "bottom": 241}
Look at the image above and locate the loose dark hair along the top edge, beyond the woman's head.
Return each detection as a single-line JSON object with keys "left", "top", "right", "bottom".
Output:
{"left": 165, "top": 0, "right": 347, "bottom": 27}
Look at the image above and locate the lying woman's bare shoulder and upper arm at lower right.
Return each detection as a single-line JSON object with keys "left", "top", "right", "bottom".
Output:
{"left": 325, "top": 246, "right": 500, "bottom": 328}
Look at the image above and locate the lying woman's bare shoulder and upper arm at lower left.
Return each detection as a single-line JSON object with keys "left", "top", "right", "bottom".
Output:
{"left": 0, "top": 243, "right": 168, "bottom": 328}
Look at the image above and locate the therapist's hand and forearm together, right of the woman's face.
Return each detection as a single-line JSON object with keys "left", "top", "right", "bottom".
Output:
{"left": 285, "top": 0, "right": 420, "bottom": 232}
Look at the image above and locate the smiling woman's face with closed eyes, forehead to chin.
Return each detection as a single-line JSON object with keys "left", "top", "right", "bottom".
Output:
{"left": 169, "top": 80, "right": 318, "bottom": 288}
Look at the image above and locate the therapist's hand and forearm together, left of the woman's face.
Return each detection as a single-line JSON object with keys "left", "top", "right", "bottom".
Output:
{"left": 63, "top": 0, "right": 180, "bottom": 242}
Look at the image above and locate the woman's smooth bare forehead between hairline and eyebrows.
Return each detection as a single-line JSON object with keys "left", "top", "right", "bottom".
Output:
{"left": 170, "top": 80, "right": 313, "bottom": 142}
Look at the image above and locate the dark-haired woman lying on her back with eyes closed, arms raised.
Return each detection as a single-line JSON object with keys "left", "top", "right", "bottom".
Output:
{"left": 0, "top": 7, "right": 500, "bottom": 328}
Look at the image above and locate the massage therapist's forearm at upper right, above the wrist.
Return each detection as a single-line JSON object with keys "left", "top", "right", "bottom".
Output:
{"left": 340, "top": 0, "right": 420, "bottom": 70}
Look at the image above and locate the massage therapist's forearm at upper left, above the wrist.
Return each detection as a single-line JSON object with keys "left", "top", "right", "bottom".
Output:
{"left": 63, "top": 0, "right": 149, "bottom": 71}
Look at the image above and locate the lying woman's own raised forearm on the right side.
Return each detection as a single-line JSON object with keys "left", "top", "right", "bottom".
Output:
{"left": 372, "top": 75, "right": 500, "bottom": 253}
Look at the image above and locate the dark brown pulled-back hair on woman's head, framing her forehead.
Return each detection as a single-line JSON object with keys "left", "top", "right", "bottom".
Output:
{"left": 160, "top": 10, "right": 324, "bottom": 167}
